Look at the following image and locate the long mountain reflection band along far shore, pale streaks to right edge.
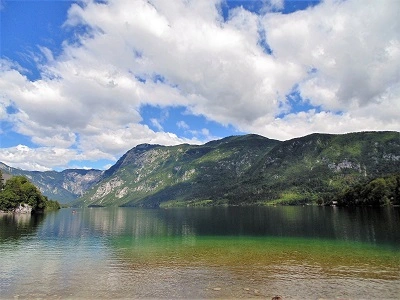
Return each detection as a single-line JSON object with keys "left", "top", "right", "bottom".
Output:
{"left": 78, "top": 206, "right": 400, "bottom": 246}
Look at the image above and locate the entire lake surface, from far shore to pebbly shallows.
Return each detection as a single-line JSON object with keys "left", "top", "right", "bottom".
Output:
{"left": 0, "top": 206, "right": 400, "bottom": 299}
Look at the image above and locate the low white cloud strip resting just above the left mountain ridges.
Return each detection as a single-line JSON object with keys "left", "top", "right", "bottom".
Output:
{"left": 0, "top": 124, "right": 200, "bottom": 171}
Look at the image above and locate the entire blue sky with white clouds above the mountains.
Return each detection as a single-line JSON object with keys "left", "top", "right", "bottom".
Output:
{"left": 0, "top": 0, "right": 400, "bottom": 171}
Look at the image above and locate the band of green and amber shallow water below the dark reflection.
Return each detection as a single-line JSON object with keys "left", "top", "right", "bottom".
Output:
{"left": 110, "top": 236, "right": 400, "bottom": 279}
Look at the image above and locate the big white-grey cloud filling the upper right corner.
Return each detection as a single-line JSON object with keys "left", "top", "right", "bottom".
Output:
{"left": 264, "top": 0, "right": 400, "bottom": 111}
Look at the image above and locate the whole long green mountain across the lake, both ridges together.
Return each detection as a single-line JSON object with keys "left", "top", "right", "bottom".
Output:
{"left": 74, "top": 132, "right": 400, "bottom": 207}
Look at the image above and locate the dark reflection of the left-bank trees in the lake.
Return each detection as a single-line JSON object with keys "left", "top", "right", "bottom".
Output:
{"left": 0, "top": 214, "right": 45, "bottom": 242}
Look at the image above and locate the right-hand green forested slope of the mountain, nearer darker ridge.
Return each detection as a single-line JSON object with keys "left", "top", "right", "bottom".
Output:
{"left": 230, "top": 132, "right": 400, "bottom": 204}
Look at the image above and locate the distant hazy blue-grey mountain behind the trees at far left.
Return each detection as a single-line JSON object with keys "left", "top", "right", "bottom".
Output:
{"left": 0, "top": 163, "right": 103, "bottom": 203}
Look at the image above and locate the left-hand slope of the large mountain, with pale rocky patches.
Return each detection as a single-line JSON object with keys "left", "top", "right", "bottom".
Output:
{"left": 75, "top": 135, "right": 280, "bottom": 207}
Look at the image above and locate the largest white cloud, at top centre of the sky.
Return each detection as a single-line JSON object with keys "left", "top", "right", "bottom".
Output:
{"left": 63, "top": 1, "right": 302, "bottom": 124}
